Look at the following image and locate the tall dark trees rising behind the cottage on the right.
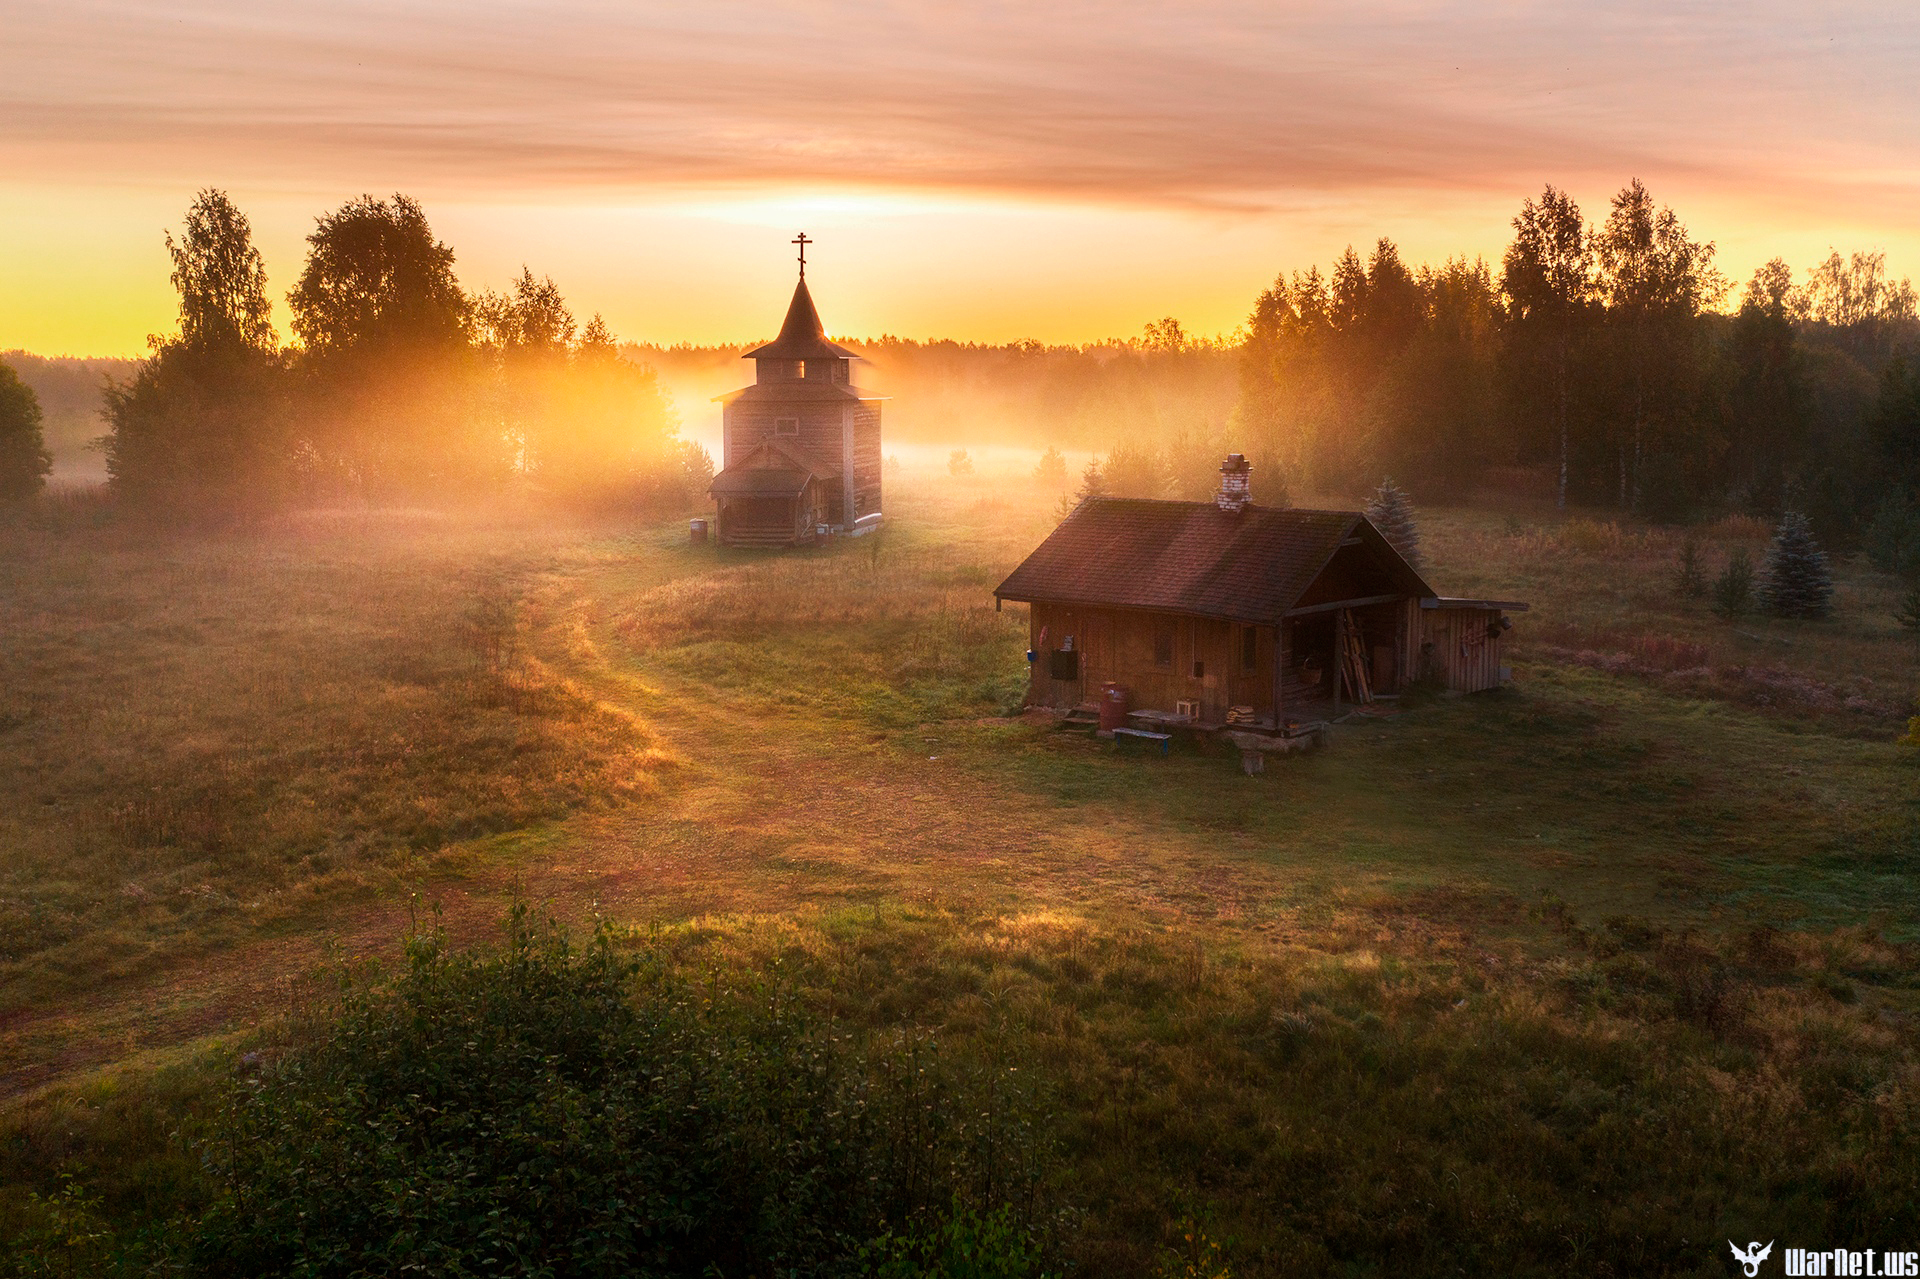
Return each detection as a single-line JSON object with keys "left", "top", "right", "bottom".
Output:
{"left": 1231, "top": 181, "right": 1920, "bottom": 545}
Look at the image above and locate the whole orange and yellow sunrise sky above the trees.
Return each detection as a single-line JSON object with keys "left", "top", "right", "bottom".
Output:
{"left": 0, "top": 0, "right": 1920, "bottom": 355}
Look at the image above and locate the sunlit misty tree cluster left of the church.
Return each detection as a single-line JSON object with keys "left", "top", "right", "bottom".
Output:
{"left": 28, "top": 190, "right": 712, "bottom": 519}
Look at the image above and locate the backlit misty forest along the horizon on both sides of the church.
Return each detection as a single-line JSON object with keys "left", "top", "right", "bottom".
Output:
{"left": 3, "top": 179, "right": 1920, "bottom": 563}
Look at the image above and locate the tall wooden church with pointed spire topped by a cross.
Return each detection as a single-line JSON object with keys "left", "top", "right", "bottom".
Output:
{"left": 708, "top": 234, "right": 881, "bottom": 547}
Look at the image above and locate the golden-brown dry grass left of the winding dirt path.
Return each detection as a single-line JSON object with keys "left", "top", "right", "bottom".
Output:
{"left": 0, "top": 506, "right": 666, "bottom": 1006}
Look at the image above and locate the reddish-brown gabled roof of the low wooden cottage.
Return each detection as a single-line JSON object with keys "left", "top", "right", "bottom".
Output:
{"left": 995, "top": 497, "right": 1434, "bottom": 626}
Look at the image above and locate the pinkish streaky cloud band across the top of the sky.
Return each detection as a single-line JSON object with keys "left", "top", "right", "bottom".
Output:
{"left": 0, "top": 0, "right": 1920, "bottom": 211}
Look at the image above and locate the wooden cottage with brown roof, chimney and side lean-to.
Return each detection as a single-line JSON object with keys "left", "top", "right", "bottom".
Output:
{"left": 995, "top": 453, "right": 1526, "bottom": 730}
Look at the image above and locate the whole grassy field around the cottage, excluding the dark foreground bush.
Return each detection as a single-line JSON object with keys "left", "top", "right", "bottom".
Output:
{"left": 0, "top": 474, "right": 1920, "bottom": 1275}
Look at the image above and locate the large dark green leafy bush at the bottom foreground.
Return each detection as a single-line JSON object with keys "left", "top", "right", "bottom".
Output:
{"left": 198, "top": 906, "right": 1039, "bottom": 1277}
